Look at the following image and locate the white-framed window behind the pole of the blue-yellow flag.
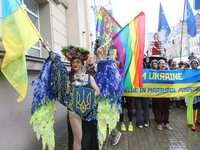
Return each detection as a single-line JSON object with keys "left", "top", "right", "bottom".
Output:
{"left": 20, "top": 0, "right": 41, "bottom": 57}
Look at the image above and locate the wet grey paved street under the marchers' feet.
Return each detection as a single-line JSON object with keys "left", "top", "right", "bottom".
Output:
{"left": 55, "top": 108, "right": 200, "bottom": 150}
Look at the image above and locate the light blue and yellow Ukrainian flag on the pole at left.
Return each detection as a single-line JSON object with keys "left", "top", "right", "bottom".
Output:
{"left": 1, "top": 0, "right": 40, "bottom": 102}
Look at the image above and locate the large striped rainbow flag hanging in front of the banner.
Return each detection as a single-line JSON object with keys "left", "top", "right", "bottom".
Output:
{"left": 113, "top": 12, "right": 145, "bottom": 90}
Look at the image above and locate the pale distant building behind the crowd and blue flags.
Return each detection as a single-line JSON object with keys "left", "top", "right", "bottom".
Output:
{"left": 165, "top": 13, "right": 200, "bottom": 59}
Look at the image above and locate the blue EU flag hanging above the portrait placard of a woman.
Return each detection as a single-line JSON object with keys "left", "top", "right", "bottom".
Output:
{"left": 158, "top": 3, "right": 171, "bottom": 43}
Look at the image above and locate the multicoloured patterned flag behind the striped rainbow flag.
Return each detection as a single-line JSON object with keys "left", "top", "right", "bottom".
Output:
{"left": 96, "top": 7, "right": 122, "bottom": 58}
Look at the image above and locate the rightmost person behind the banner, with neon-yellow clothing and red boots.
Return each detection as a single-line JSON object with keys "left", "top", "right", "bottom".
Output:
{"left": 186, "top": 59, "right": 200, "bottom": 131}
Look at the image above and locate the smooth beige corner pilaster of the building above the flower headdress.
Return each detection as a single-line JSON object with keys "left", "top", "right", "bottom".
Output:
{"left": 67, "top": 0, "right": 91, "bottom": 51}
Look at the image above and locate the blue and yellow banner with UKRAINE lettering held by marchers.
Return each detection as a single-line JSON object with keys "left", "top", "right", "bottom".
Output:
{"left": 123, "top": 69, "right": 200, "bottom": 98}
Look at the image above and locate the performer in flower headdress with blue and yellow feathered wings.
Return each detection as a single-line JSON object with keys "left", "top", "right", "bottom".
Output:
{"left": 30, "top": 41, "right": 122, "bottom": 150}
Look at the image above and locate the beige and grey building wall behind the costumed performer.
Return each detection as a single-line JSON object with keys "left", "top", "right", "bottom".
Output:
{"left": 0, "top": 0, "right": 91, "bottom": 150}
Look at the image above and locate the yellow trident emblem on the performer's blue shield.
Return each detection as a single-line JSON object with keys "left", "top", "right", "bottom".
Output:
{"left": 76, "top": 90, "right": 92, "bottom": 113}
